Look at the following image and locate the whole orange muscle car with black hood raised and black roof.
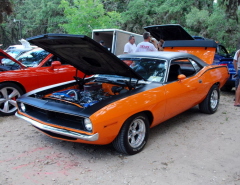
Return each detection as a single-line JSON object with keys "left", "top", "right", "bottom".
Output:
{"left": 16, "top": 34, "right": 229, "bottom": 155}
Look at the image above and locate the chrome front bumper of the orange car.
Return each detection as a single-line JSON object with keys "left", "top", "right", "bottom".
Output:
{"left": 15, "top": 112, "right": 99, "bottom": 141}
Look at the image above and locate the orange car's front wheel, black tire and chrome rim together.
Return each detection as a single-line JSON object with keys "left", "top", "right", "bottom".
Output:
{"left": 113, "top": 113, "right": 149, "bottom": 155}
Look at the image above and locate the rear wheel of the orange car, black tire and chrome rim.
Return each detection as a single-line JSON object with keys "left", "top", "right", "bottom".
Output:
{"left": 199, "top": 85, "right": 220, "bottom": 114}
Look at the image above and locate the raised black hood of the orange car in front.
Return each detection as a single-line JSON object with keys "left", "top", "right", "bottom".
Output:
{"left": 27, "top": 34, "right": 143, "bottom": 79}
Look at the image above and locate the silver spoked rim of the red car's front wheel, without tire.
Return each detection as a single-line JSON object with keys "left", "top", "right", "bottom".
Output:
{"left": 0, "top": 87, "right": 21, "bottom": 113}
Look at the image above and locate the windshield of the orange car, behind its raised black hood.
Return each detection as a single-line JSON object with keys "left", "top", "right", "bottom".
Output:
{"left": 121, "top": 58, "right": 167, "bottom": 82}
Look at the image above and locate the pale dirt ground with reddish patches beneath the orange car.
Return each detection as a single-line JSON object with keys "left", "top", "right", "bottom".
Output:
{"left": 0, "top": 91, "right": 240, "bottom": 185}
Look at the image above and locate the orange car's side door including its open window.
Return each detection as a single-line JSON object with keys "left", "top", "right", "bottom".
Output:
{"left": 165, "top": 59, "right": 201, "bottom": 118}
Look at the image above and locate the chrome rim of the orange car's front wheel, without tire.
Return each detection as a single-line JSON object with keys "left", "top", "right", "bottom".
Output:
{"left": 128, "top": 119, "right": 146, "bottom": 148}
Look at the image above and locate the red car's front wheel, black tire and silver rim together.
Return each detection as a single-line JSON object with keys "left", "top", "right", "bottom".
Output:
{"left": 0, "top": 82, "right": 23, "bottom": 116}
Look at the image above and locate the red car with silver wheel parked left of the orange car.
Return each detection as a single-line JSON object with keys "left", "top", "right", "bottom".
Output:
{"left": 0, "top": 48, "right": 84, "bottom": 116}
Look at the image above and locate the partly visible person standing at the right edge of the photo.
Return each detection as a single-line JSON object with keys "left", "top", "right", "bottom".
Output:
{"left": 233, "top": 50, "right": 240, "bottom": 107}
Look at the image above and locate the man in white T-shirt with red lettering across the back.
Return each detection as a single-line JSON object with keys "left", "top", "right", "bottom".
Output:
{"left": 136, "top": 32, "right": 158, "bottom": 52}
